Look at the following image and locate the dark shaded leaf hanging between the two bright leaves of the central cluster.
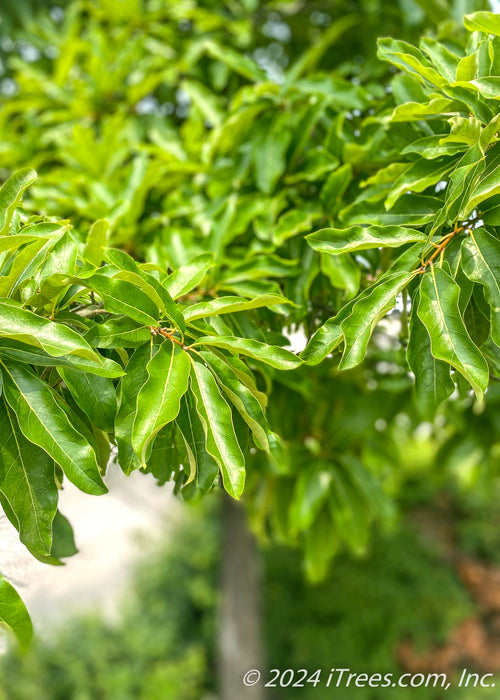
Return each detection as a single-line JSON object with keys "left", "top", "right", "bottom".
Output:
{"left": 175, "top": 391, "right": 219, "bottom": 493}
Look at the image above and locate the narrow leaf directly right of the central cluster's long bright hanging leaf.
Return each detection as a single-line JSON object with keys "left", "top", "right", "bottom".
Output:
{"left": 200, "top": 352, "right": 269, "bottom": 451}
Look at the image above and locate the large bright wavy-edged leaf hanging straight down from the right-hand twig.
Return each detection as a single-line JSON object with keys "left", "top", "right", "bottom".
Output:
{"left": 417, "top": 265, "right": 489, "bottom": 399}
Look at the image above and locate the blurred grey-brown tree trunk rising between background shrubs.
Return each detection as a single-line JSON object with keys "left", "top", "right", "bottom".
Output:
{"left": 218, "top": 496, "right": 264, "bottom": 700}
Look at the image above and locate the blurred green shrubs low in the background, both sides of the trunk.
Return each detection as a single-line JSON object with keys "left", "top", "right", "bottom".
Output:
{"left": 4, "top": 492, "right": 500, "bottom": 700}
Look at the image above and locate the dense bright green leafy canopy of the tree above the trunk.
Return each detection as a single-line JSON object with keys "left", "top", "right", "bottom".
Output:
{"left": 0, "top": 0, "right": 500, "bottom": 639}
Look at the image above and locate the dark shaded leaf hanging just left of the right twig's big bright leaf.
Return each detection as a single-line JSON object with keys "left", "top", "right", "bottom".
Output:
{"left": 407, "top": 288, "right": 455, "bottom": 420}
